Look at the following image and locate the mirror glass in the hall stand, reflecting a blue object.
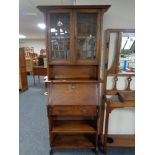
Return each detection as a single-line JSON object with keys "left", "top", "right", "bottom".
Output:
{"left": 119, "top": 33, "right": 135, "bottom": 73}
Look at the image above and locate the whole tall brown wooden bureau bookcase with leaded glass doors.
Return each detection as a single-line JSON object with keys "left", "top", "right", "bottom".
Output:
{"left": 38, "top": 5, "right": 110, "bottom": 154}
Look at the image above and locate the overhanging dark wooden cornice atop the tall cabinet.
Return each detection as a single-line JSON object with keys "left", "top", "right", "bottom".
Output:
{"left": 37, "top": 5, "right": 111, "bottom": 12}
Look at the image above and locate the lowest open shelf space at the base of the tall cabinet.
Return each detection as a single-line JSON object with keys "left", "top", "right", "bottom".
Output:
{"left": 52, "top": 135, "right": 95, "bottom": 148}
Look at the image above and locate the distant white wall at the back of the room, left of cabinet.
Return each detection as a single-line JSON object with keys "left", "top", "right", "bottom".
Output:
{"left": 19, "top": 39, "right": 46, "bottom": 53}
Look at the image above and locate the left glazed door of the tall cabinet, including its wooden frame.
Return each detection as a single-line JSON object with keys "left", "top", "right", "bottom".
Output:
{"left": 48, "top": 10, "right": 72, "bottom": 64}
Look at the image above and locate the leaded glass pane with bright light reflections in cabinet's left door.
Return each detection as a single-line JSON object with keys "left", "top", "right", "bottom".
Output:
{"left": 50, "top": 13, "right": 70, "bottom": 60}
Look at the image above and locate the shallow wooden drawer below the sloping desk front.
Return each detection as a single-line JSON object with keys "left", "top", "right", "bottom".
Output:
{"left": 48, "top": 106, "right": 97, "bottom": 116}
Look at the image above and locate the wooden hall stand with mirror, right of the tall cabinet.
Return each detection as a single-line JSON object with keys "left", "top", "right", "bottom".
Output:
{"left": 101, "top": 29, "right": 135, "bottom": 152}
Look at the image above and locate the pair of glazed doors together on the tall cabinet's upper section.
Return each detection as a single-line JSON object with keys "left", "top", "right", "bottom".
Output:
{"left": 47, "top": 9, "right": 101, "bottom": 65}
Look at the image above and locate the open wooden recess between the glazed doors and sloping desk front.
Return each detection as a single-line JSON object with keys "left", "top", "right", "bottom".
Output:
{"left": 48, "top": 66, "right": 98, "bottom": 80}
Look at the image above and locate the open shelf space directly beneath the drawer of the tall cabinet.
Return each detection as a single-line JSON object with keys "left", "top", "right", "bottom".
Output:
{"left": 51, "top": 120, "right": 97, "bottom": 133}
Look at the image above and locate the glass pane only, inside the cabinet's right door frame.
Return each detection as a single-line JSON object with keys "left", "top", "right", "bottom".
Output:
{"left": 77, "top": 13, "right": 97, "bottom": 60}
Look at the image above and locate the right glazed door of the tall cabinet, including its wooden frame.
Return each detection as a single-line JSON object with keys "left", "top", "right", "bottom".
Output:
{"left": 75, "top": 9, "right": 100, "bottom": 65}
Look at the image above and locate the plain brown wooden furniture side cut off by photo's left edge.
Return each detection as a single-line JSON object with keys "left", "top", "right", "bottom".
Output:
{"left": 19, "top": 48, "right": 28, "bottom": 91}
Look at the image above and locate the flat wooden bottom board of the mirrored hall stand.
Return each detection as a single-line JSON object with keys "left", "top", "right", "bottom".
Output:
{"left": 107, "top": 135, "right": 135, "bottom": 147}
